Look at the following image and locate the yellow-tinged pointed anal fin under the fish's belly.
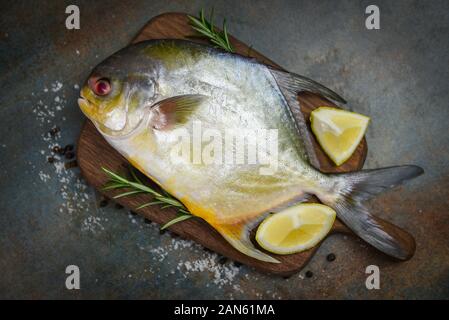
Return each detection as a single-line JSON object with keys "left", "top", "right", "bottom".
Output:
{"left": 213, "top": 215, "right": 280, "bottom": 263}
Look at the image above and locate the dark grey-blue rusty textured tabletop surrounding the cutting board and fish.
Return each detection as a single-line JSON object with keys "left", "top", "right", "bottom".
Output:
{"left": 0, "top": 0, "right": 449, "bottom": 299}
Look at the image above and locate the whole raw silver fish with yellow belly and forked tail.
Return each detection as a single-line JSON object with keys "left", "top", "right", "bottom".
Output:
{"left": 78, "top": 40, "right": 423, "bottom": 262}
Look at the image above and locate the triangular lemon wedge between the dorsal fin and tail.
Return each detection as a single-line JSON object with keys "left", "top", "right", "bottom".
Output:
{"left": 310, "top": 107, "right": 370, "bottom": 166}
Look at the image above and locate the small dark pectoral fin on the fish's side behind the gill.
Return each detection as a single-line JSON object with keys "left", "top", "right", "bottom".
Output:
{"left": 149, "top": 94, "right": 208, "bottom": 130}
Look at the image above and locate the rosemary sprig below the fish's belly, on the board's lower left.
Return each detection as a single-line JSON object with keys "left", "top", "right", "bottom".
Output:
{"left": 101, "top": 167, "right": 193, "bottom": 230}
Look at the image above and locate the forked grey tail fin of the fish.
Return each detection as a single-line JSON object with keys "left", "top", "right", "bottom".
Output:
{"left": 319, "top": 165, "right": 424, "bottom": 260}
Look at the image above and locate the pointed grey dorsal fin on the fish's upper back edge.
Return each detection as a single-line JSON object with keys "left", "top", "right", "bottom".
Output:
{"left": 268, "top": 67, "right": 346, "bottom": 169}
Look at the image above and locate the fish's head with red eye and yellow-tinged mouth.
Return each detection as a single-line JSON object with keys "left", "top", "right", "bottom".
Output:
{"left": 78, "top": 52, "right": 156, "bottom": 136}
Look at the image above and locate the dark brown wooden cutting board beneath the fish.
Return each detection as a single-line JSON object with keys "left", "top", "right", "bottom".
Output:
{"left": 77, "top": 13, "right": 368, "bottom": 275}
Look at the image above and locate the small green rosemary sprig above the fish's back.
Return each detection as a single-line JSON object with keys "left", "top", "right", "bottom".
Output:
{"left": 188, "top": 9, "right": 234, "bottom": 52}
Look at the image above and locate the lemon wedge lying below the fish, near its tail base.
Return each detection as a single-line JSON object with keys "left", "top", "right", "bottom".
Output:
{"left": 256, "top": 203, "right": 336, "bottom": 254}
